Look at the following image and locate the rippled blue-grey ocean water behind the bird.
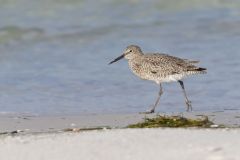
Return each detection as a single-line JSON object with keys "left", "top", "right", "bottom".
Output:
{"left": 0, "top": 0, "right": 240, "bottom": 115}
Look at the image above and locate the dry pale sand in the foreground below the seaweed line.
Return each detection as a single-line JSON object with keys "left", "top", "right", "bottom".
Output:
{"left": 0, "top": 128, "right": 240, "bottom": 160}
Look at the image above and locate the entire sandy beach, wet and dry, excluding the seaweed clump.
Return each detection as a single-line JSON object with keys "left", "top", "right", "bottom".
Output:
{"left": 0, "top": 111, "right": 240, "bottom": 160}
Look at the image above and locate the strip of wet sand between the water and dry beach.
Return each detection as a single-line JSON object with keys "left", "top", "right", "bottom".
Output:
{"left": 0, "top": 110, "right": 240, "bottom": 133}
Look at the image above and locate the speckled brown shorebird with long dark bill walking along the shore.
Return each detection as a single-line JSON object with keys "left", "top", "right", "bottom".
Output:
{"left": 109, "top": 45, "right": 207, "bottom": 113}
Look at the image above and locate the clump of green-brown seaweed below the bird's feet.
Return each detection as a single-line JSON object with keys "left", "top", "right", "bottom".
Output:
{"left": 127, "top": 115, "right": 214, "bottom": 128}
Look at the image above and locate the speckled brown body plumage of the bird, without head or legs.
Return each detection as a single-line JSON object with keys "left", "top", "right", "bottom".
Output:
{"left": 128, "top": 53, "right": 206, "bottom": 84}
